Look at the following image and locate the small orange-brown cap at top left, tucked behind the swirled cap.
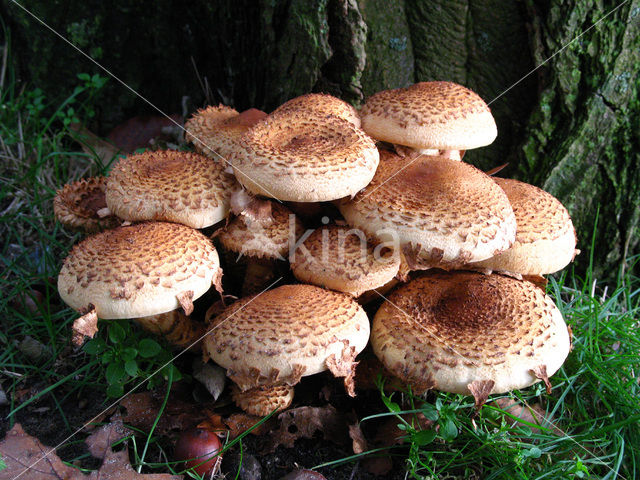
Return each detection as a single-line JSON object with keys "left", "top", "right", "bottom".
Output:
{"left": 184, "top": 105, "right": 267, "bottom": 160}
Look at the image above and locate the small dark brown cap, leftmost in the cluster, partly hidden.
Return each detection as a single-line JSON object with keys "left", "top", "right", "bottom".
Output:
{"left": 53, "top": 177, "right": 121, "bottom": 232}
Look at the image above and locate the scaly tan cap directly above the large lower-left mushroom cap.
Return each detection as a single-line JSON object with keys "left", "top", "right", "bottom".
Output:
{"left": 106, "top": 150, "right": 235, "bottom": 228}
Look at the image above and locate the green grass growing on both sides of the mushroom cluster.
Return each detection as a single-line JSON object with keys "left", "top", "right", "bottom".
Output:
{"left": 0, "top": 46, "right": 640, "bottom": 480}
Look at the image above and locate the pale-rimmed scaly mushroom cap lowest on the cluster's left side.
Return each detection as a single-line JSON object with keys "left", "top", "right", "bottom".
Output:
{"left": 58, "top": 222, "right": 220, "bottom": 319}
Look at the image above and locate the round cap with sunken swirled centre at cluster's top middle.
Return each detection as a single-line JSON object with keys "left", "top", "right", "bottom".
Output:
{"left": 230, "top": 109, "right": 378, "bottom": 202}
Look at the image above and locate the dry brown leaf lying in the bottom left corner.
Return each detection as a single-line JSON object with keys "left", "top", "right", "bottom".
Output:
{"left": 0, "top": 423, "right": 86, "bottom": 480}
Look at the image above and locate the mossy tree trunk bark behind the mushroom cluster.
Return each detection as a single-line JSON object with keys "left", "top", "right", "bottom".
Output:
{"left": 0, "top": 0, "right": 640, "bottom": 275}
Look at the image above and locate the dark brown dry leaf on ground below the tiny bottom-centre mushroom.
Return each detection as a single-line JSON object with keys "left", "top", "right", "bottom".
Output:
{"left": 265, "top": 405, "right": 349, "bottom": 453}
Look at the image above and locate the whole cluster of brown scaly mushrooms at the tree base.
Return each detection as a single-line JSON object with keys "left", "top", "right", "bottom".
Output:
{"left": 55, "top": 82, "right": 577, "bottom": 415}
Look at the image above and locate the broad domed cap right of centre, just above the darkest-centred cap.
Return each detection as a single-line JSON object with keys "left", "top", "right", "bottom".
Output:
{"left": 339, "top": 150, "right": 516, "bottom": 269}
